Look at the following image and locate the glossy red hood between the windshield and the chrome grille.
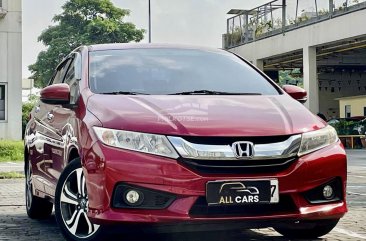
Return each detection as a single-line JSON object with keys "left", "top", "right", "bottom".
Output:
{"left": 87, "top": 94, "right": 325, "bottom": 136}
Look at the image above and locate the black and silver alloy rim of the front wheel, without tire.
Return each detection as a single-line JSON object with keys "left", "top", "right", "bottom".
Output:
{"left": 59, "top": 168, "right": 100, "bottom": 239}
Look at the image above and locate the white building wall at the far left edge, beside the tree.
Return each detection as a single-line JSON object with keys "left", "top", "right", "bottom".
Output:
{"left": 0, "top": 0, "right": 22, "bottom": 140}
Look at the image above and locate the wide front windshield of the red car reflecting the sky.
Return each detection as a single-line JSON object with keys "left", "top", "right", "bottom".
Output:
{"left": 89, "top": 48, "right": 279, "bottom": 95}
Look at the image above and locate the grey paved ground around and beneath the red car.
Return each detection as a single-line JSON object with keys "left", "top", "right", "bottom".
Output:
{"left": 0, "top": 150, "right": 366, "bottom": 241}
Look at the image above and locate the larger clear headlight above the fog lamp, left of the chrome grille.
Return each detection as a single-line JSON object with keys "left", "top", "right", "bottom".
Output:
{"left": 93, "top": 127, "right": 179, "bottom": 159}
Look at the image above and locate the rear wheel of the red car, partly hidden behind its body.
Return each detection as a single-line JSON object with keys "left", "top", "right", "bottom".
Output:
{"left": 25, "top": 162, "right": 53, "bottom": 219}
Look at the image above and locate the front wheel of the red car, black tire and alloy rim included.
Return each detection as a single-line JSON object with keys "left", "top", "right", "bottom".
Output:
{"left": 55, "top": 159, "right": 103, "bottom": 241}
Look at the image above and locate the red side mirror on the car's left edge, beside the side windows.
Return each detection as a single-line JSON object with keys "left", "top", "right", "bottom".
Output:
{"left": 40, "top": 83, "right": 70, "bottom": 105}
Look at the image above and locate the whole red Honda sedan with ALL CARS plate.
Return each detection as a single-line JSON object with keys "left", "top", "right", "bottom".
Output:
{"left": 24, "top": 44, "right": 347, "bottom": 241}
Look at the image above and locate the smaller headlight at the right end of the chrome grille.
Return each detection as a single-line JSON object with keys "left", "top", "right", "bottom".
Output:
{"left": 298, "top": 125, "right": 338, "bottom": 156}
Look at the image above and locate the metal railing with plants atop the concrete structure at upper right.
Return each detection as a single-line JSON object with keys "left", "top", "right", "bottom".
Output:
{"left": 223, "top": 0, "right": 366, "bottom": 49}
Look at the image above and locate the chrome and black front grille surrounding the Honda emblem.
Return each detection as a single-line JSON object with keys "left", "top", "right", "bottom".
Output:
{"left": 168, "top": 135, "right": 301, "bottom": 174}
